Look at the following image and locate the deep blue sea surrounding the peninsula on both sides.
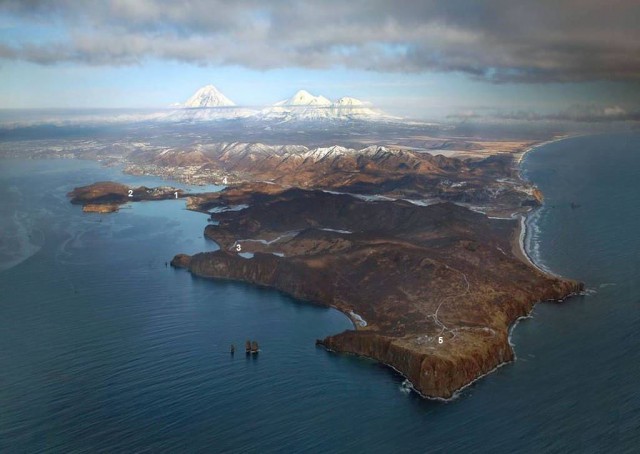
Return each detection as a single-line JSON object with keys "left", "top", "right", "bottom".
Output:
{"left": 0, "top": 134, "right": 640, "bottom": 453}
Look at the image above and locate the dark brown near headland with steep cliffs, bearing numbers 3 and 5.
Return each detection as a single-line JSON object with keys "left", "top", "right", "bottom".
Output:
{"left": 171, "top": 189, "right": 582, "bottom": 399}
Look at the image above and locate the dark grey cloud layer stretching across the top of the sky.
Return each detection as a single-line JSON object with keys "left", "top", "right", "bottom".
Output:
{"left": 0, "top": 0, "right": 640, "bottom": 82}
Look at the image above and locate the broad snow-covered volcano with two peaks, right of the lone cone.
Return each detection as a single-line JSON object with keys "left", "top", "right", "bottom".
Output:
{"left": 260, "top": 90, "right": 393, "bottom": 121}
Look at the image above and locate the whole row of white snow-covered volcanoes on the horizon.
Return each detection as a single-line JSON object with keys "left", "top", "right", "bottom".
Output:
{"left": 170, "top": 85, "right": 399, "bottom": 122}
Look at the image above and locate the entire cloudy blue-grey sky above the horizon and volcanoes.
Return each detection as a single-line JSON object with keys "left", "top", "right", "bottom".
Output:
{"left": 0, "top": 0, "right": 640, "bottom": 121}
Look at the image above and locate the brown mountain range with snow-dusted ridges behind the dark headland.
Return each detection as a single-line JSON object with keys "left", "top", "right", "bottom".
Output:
{"left": 143, "top": 142, "right": 463, "bottom": 193}
